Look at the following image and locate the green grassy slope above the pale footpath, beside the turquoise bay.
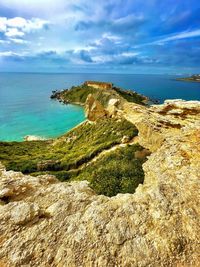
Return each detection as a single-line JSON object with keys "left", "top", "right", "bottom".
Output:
{"left": 0, "top": 118, "right": 137, "bottom": 173}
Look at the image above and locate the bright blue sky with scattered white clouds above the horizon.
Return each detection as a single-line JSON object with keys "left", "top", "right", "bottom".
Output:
{"left": 0, "top": 0, "right": 200, "bottom": 74}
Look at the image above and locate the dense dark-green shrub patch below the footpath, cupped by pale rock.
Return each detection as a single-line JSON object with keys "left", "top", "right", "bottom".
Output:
{"left": 74, "top": 145, "right": 146, "bottom": 196}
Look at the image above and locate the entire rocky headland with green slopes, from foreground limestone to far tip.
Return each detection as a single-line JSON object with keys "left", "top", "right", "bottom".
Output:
{"left": 0, "top": 81, "right": 200, "bottom": 267}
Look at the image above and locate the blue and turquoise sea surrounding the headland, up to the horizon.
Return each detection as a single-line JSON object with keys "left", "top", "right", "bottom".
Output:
{"left": 0, "top": 73, "right": 200, "bottom": 141}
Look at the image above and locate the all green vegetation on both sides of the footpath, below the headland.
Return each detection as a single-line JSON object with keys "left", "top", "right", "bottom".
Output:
{"left": 0, "top": 118, "right": 146, "bottom": 196}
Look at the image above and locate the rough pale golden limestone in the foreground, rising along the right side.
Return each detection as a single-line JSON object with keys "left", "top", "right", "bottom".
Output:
{"left": 0, "top": 101, "right": 200, "bottom": 267}
